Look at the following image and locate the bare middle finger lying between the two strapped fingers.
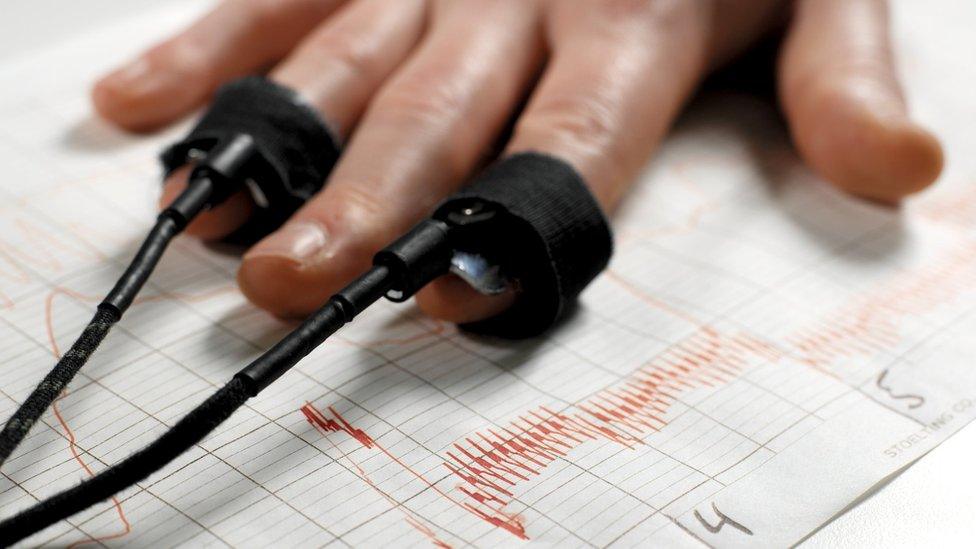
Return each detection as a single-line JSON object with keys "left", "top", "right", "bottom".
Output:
{"left": 238, "top": 0, "right": 542, "bottom": 316}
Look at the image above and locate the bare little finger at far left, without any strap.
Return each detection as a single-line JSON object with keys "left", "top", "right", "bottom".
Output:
{"left": 92, "top": 0, "right": 343, "bottom": 131}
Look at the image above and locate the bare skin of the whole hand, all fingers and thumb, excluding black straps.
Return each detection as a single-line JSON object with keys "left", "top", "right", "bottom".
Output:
{"left": 92, "top": 0, "right": 942, "bottom": 322}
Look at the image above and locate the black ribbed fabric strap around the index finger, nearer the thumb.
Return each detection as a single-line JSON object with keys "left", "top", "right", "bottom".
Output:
{"left": 433, "top": 152, "right": 613, "bottom": 338}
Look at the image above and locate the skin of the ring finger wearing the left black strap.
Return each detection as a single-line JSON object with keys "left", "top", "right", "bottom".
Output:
{"left": 160, "top": 0, "right": 425, "bottom": 240}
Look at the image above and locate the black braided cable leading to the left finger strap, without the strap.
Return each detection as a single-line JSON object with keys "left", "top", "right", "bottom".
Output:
{"left": 0, "top": 178, "right": 213, "bottom": 466}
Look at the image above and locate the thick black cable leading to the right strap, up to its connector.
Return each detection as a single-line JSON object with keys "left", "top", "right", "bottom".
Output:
{"left": 0, "top": 265, "right": 396, "bottom": 546}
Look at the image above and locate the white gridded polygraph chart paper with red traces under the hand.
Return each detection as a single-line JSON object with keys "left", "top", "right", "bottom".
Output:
{"left": 0, "top": 0, "right": 976, "bottom": 547}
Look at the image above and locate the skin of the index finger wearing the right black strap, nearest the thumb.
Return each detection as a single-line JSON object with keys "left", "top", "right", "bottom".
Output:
{"left": 417, "top": 0, "right": 768, "bottom": 323}
